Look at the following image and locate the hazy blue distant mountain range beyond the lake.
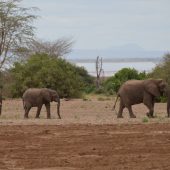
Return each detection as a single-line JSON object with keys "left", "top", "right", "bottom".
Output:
{"left": 67, "top": 44, "right": 166, "bottom": 60}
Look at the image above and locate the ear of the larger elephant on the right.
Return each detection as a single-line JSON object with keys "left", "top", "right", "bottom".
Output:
{"left": 144, "top": 81, "right": 161, "bottom": 97}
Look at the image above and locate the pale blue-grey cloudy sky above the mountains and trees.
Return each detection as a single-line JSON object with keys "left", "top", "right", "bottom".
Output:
{"left": 22, "top": 0, "right": 170, "bottom": 51}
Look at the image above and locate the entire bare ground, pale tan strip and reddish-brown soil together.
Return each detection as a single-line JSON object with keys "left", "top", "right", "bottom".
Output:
{"left": 0, "top": 98, "right": 170, "bottom": 170}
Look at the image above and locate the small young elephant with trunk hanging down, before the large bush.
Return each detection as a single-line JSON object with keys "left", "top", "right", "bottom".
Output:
{"left": 22, "top": 88, "right": 61, "bottom": 119}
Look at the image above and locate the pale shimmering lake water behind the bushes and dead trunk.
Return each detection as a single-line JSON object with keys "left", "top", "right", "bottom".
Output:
{"left": 75, "top": 62, "right": 156, "bottom": 76}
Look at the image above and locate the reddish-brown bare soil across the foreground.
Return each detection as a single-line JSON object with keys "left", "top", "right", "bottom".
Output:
{"left": 0, "top": 123, "right": 170, "bottom": 170}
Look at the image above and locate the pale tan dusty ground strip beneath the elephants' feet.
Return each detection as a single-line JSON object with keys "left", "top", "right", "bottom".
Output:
{"left": 0, "top": 97, "right": 170, "bottom": 125}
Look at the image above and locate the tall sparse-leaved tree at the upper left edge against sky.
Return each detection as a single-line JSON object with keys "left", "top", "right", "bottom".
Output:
{"left": 0, "top": 0, "right": 37, "bottom": 69}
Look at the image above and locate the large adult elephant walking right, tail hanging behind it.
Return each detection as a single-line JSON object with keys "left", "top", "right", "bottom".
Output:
{"left": 113, "top": 79, "right": 168, "bottom": 118}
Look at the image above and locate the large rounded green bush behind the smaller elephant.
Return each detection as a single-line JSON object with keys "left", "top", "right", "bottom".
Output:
{"left": 10, "top": 54, "right": 92, "bottom": 97}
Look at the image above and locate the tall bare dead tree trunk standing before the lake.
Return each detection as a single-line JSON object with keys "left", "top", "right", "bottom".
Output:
{"left": 96, "top": 56, "right": 103, "bottom": 88}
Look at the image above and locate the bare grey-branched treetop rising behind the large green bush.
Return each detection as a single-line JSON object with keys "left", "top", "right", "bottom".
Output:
{"left": 17, "top": 38, "right": 73, "bottom": 59}
